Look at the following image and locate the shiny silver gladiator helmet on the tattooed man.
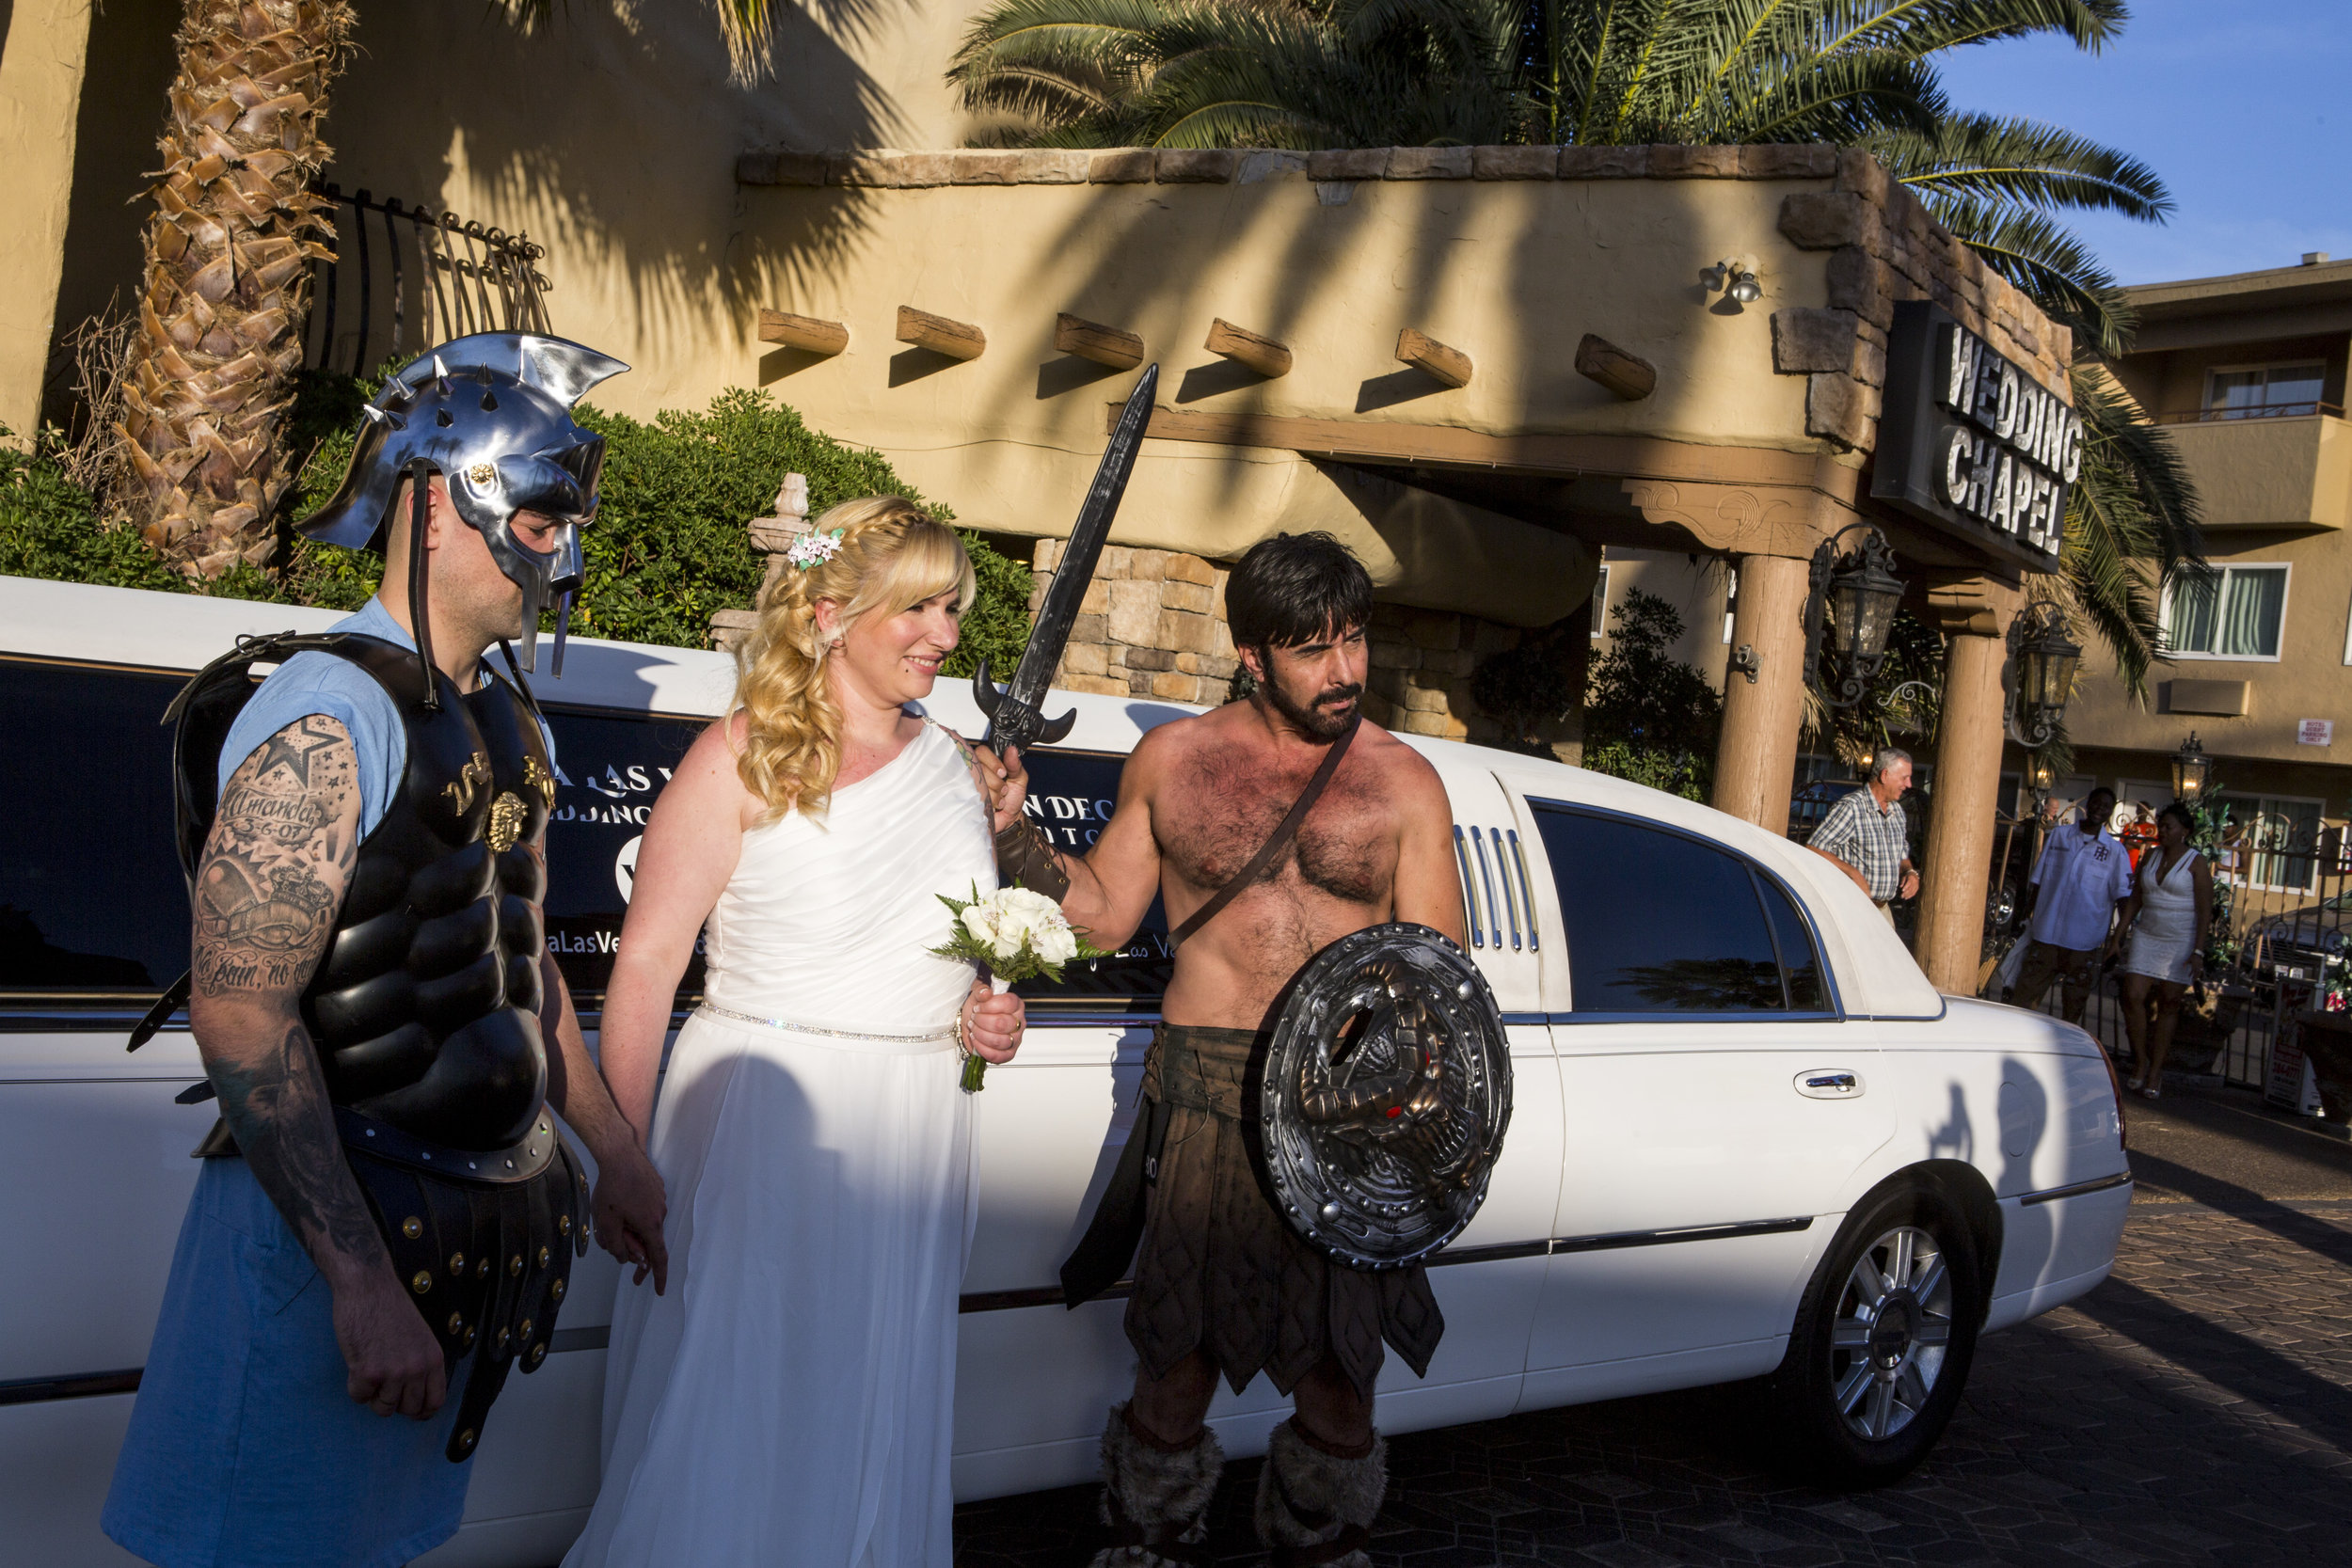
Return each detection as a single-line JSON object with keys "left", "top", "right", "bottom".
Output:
{"left": 294, "top": 331, "right": 628, "bottom": 674}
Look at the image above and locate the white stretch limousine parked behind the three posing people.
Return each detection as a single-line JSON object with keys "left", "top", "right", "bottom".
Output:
{"left": 0, "top": 578, "right": 2131, "bottom": 1568}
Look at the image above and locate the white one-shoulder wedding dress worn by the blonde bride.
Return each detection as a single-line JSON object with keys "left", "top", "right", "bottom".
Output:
{"left": 564, "top": 721, "right": 995, "bottom": 1568}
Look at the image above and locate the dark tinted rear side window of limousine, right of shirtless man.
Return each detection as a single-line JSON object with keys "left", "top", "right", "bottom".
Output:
{"left": 1536, "top": 806, "right": 1828, "bottom": 1016}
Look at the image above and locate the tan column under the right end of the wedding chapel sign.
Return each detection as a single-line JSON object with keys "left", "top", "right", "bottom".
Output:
{"left": 1917, "top": 627, "right": 2007, "bottom": 997}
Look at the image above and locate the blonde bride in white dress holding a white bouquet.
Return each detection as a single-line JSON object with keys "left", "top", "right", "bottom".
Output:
{"left": 564, "top": 496, "right": 1024, "bottom": 1568}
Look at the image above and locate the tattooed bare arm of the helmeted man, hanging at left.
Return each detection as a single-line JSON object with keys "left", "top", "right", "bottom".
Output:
{"left": 188, "top": 715, "right": 447, "bottom": 1420}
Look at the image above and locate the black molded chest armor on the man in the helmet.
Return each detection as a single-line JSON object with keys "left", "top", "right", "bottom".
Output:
{"left": 301, "top": 635, "right": 555, "bottom": 1149}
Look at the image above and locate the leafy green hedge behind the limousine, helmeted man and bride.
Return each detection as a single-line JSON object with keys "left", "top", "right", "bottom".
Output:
{"left": 0, "top": 385, "right": 1030, "bottom": 677}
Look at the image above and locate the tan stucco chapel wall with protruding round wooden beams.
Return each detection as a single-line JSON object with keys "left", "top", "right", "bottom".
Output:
{"left": 715, "top": 166, "right": 1825, "bottom": 626}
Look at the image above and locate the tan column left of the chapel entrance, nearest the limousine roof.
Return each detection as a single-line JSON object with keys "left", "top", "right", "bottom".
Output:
{"left": 1715, "top": 555, "right": 1811, "bottom": 832}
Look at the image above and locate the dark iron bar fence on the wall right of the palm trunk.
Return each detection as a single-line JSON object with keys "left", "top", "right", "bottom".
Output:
{"left": 304, "top": 185, "right": 553, "bottom": 376}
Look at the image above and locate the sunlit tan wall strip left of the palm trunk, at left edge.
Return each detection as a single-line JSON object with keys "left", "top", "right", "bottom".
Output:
{"left": 0, "top": 0, "right": 95, "bottom": 444}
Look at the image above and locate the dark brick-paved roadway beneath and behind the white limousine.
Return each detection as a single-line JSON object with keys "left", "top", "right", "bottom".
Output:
{"left": 955, "top": 1091, "right": 2352, "bottom": 1568}
